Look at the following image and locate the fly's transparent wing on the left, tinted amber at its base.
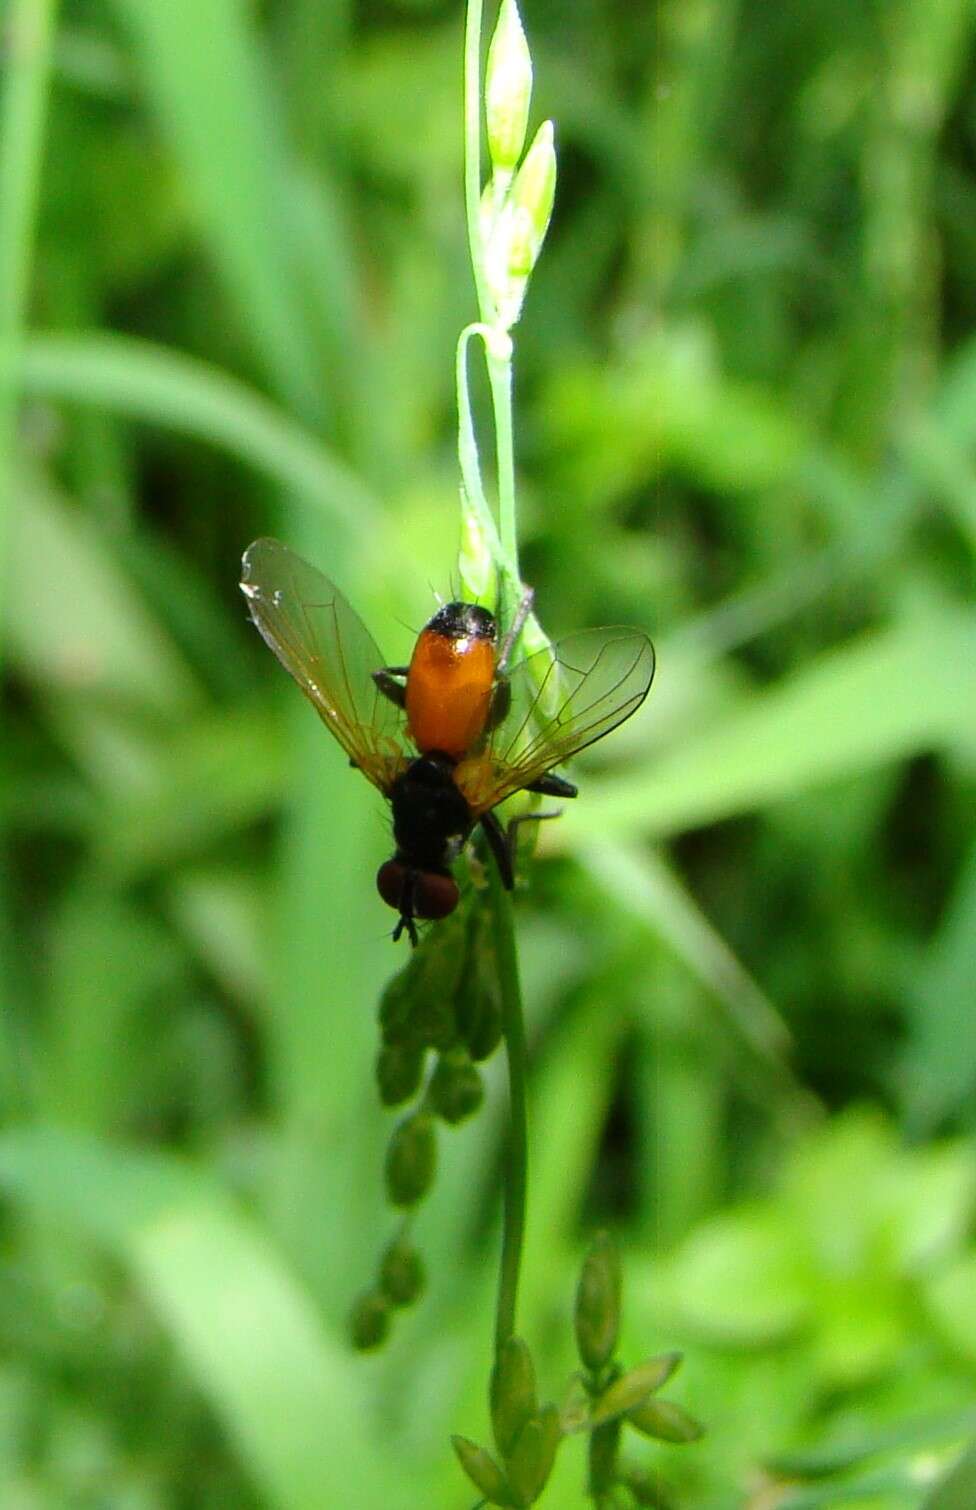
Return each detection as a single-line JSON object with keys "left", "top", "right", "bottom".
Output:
{"left": 240, "top": 539, "right": 405, "bottom": 791}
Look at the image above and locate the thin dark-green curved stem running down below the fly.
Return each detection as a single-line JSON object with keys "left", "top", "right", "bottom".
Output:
{"left": 488, "top": 865, "right": 529, "bottom": 1351}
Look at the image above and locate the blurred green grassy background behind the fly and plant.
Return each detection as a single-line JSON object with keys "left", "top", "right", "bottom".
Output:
{"left": 0, "top": 0, "right": 976, "bottom": 1510}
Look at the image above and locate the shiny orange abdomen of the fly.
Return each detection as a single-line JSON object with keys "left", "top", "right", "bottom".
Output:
{"left": 406, "top": 627, "right": 496, "bottom": 760}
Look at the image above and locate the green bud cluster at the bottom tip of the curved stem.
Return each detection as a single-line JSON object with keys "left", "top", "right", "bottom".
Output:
{"left": 452, "top": 1336, "right": 564, "bottom": 1507}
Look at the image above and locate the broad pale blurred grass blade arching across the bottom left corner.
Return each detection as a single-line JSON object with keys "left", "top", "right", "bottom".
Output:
{"left": 0, "top": 1129, "right": 403, "bottom": 1510}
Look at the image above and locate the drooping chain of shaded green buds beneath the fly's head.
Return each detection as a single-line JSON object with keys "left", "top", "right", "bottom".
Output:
{"left": 349, "top": 892, "right": 502, "bottom": 1351}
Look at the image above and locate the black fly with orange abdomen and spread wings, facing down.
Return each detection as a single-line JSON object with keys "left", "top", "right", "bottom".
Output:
{"left": 240, "top": 539, "right": 654, "bottom": 944}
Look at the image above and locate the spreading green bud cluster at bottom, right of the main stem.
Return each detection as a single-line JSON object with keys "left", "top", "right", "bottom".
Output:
{"left": 562, "top": 1232, "right": 703, "bottom": 1505}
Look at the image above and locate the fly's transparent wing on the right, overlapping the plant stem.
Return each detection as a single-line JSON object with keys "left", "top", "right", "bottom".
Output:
{"left": 456, "top": 628, "right": 654, "bottom": 814}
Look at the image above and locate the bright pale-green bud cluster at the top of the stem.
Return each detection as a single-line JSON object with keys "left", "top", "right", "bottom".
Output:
{"left": 480, "top": 0, "right": 556, "bottom": 331}
